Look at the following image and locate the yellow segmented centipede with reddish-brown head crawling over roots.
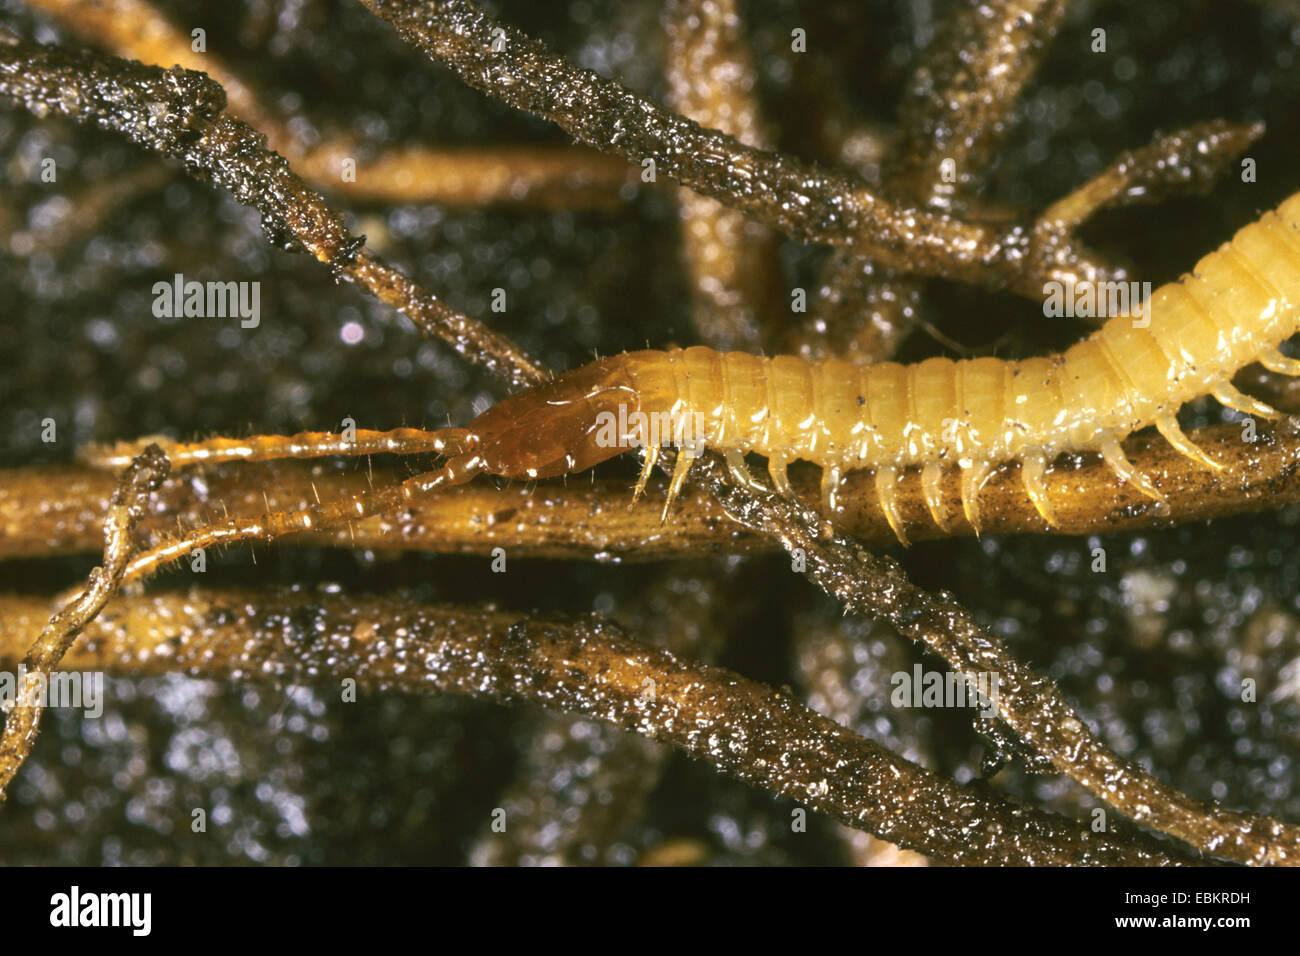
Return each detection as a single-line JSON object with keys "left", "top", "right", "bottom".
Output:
{"left": 87, "top": 193, "right": 1300, "bottom": 544}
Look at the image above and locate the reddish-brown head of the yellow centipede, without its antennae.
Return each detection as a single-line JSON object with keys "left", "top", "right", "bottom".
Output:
{"left": 468, "top": 356, "right": 638, "bottom": 479}
